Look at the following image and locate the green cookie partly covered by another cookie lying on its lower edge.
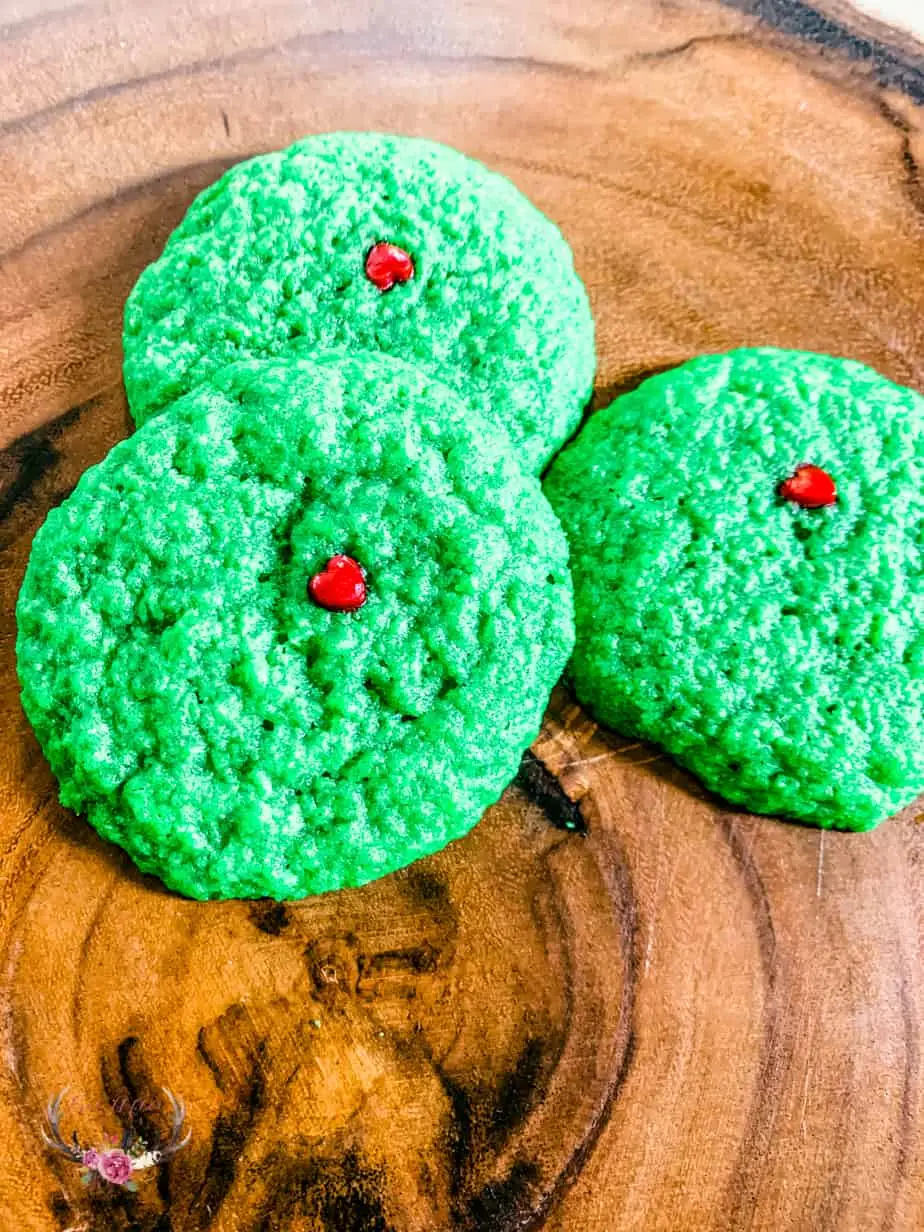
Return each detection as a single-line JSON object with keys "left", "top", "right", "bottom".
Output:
{"left": 124, "top": 133, "right": 595, "bottom": 471}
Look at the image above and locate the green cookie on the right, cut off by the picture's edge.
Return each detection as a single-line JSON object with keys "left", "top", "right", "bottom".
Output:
{"left": 546, "top": 349, "right": 924, "bottom": 829}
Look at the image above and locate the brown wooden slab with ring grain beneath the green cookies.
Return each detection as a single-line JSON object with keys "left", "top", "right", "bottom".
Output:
{"left": 0, "top": 0, "right": 924, "bottom": 1232}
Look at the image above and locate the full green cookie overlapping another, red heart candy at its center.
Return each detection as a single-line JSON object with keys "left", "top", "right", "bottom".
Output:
{"left": 17, "top": 355, "right": 573, "bottom": 898}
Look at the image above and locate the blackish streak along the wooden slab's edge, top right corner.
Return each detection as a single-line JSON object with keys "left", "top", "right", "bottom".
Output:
{"left": 723, "top": 0, "right": 924, "bottom": 103}
